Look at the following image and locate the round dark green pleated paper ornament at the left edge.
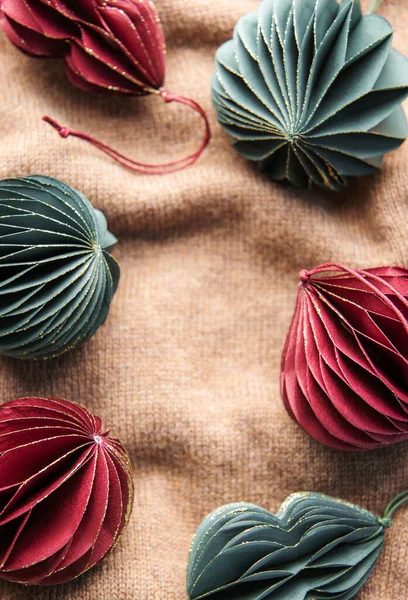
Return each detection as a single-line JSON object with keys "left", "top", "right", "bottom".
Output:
{"left": 0, "top": 176, "right": 119, "bottom": 358}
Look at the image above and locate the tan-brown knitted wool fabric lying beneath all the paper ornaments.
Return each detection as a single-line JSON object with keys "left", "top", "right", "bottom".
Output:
{"left": 0, "top": 0, "right": 408, "bottom": 600}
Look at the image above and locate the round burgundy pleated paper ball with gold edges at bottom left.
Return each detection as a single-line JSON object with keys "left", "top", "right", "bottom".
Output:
{"left": 0, "top": 398, "right": 133, "bottom": 585}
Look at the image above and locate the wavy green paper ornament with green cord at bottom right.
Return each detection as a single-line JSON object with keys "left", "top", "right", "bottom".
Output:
{"left": 187, "top": 492, "right": 408, "bottom": 600}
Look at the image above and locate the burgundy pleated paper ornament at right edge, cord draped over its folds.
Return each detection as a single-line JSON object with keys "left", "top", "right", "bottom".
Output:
{"left": 281, "top": 263, "right": 408, "bottom": 450}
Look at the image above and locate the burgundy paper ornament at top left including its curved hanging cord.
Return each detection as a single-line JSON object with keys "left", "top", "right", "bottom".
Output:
{"left": 0, "top": 0, "right": 211, "bottom": 174}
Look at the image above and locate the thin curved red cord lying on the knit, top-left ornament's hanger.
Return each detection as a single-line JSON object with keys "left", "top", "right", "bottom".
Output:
{"left": 43, "top": 88, "right": 211, "bottom": 175}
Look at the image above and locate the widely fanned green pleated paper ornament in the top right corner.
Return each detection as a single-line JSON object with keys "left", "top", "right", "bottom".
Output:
{"left": 212, "top": 0, "right": 408, "bottom": 190}
